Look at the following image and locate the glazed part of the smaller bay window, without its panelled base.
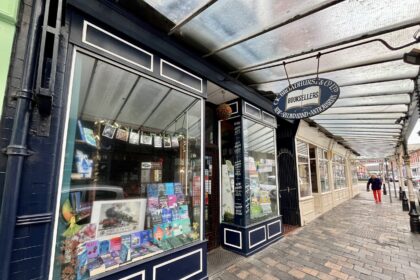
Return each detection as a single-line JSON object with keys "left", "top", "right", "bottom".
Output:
{"left": 220, "top": 104, "right": 279, "bottom": 225}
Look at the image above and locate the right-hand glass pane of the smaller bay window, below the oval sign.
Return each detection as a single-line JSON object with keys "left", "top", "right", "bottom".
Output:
{"left": 243, "top": 118, "right": 278, "bottom": 223}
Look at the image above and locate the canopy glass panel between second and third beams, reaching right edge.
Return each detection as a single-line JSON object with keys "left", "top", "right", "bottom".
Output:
{"left": 220, "top": 0, "right": 420, "bottom": 67}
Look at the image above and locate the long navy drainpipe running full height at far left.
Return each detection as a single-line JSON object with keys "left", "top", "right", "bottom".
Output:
{"left": 0, "top": 0, "right": 43, "bottom": 280}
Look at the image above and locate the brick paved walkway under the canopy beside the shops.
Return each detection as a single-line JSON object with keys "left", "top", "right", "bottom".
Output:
{"left": 210, "top": 186, "right": 420, "bottom": 280}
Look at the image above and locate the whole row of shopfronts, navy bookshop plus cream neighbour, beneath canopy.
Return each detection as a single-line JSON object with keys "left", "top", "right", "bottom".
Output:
{"left": 0, "top": 0, "right": 358, "bottom": 279}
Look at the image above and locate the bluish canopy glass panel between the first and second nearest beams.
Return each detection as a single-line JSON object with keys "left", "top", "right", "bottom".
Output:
{"left": 177, "top": 0, "right": 331, "bottom": 50}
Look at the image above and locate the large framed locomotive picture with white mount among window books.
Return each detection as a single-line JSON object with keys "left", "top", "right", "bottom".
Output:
{"left": 91, "top": 198, "right": 146, "bottom": 238}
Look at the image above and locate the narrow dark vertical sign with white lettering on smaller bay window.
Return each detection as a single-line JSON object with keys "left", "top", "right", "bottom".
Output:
{"left": 233, "top": 120, "right": 244, "bottom": 224}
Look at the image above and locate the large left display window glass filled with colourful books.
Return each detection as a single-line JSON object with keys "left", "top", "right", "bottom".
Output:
{"left": 53, "top": 52, "right": 203, "bottom": 279}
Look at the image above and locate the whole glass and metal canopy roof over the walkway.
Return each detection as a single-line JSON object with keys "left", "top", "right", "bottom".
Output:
{"left": 138, "top": 0, "right": 420, "bottom": 158}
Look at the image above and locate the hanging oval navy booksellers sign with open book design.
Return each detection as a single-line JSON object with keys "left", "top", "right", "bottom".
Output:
{"left": 273, "top": 78, "right": 340, "bottom": 120}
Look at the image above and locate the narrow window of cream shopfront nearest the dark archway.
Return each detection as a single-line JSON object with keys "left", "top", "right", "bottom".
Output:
{"left": 296, "top": 140, "right": 312, "bottom": 198}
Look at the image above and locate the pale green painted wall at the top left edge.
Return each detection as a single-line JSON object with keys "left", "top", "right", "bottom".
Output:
{"left": 0, "top": 0, "right": 20, "bottom": 116}
